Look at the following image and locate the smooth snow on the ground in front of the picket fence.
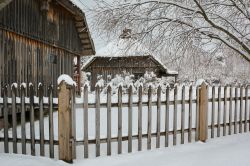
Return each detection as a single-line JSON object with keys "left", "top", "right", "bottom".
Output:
{"left": 0, "top": 133, "right": 250, "bottom": 166}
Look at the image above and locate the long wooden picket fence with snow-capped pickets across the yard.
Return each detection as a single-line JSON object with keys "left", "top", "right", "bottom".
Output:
{"left": 0, "top": 81, "right": 250, "bottom": 161}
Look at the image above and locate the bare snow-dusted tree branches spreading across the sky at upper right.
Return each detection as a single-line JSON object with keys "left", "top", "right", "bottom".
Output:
{"left": 90, "top": 0, "right": 250, "bottom": 62}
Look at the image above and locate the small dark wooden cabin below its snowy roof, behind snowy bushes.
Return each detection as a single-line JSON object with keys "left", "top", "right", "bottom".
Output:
{"left": 82, "top": 55, "right": 178, "bottom": 90}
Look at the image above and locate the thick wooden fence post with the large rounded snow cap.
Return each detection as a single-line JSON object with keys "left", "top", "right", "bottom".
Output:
{"left": 58, "top": 81, "right": 73, "bottom": 163}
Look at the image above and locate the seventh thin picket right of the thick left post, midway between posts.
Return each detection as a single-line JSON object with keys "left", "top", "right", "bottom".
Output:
{"left": 138, "top": 85, "right": 142, "bottom": 151}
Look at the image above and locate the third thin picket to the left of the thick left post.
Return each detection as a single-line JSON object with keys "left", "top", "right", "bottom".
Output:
{"left": 29, "top": 84, "right": 36, "bottom": 156}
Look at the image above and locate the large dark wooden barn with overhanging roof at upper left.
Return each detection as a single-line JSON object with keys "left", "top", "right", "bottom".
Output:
{"left": 0, "top": 0, "right": 95, "bottom": 93}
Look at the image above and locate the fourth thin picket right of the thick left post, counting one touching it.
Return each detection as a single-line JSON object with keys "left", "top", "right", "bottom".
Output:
{"left": 107, "top": 86, "right": 112, "bottom": 156}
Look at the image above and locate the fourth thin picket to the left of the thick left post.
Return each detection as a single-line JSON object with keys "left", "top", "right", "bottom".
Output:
{"left": 20, "top": 85, "right": 26, "bottom": 154}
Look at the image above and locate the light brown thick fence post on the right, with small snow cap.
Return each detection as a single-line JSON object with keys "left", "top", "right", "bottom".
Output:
{"left": 199, "top": 82, "right": 208, "bottom": 142}
